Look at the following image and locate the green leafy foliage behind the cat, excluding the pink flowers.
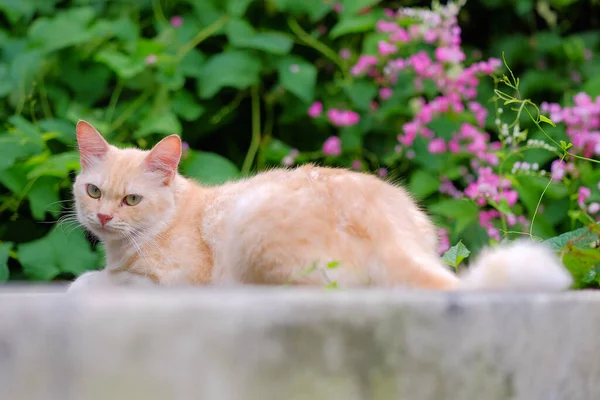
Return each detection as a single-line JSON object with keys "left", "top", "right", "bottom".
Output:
{"left": 0, "top": 0, "right": 600, "bottom": 287}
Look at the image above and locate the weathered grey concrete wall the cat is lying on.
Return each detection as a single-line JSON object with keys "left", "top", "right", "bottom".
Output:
{"left": 0, "top": 288, "right": 600, "bottom": 400}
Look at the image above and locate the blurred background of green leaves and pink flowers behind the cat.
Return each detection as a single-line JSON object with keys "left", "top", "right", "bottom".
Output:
{"left": 0, "top": 0, "right": 600, "bottom": 287}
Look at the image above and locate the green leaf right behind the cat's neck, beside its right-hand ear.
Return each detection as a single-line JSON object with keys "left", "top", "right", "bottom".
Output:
{"left": 181, "top": 150, "right": 240, "bottom": 185}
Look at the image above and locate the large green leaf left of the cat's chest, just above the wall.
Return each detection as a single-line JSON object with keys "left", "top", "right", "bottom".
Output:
{"left": 17, "top": 226, "right": 97, "bottom": 281}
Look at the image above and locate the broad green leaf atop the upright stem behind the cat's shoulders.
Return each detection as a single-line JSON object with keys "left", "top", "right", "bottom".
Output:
{"left": 199, "top": 50, "right": 262, "bottom": 99}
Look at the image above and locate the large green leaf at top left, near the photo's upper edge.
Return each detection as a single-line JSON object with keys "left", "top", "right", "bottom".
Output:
{"left": 29, "top": 7, "right": 95, "bottom": 52}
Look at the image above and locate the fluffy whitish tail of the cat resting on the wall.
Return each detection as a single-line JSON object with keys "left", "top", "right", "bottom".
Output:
{"left": 458, "top": 240, "right": 573, "bottom": 291}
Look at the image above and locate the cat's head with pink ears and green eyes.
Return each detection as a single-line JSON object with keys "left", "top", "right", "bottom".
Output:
{"left": 73, "top": 121, "right": 181, "bottom": 241}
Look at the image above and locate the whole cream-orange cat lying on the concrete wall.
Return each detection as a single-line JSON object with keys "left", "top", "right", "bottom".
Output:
{"left": 68, "top": 121, "right": 573, "bottom": 291}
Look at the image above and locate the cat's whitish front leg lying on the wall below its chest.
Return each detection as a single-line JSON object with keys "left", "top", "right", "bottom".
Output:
{"left": 67, "top": 268, "right": 156, "bottom": 292}
